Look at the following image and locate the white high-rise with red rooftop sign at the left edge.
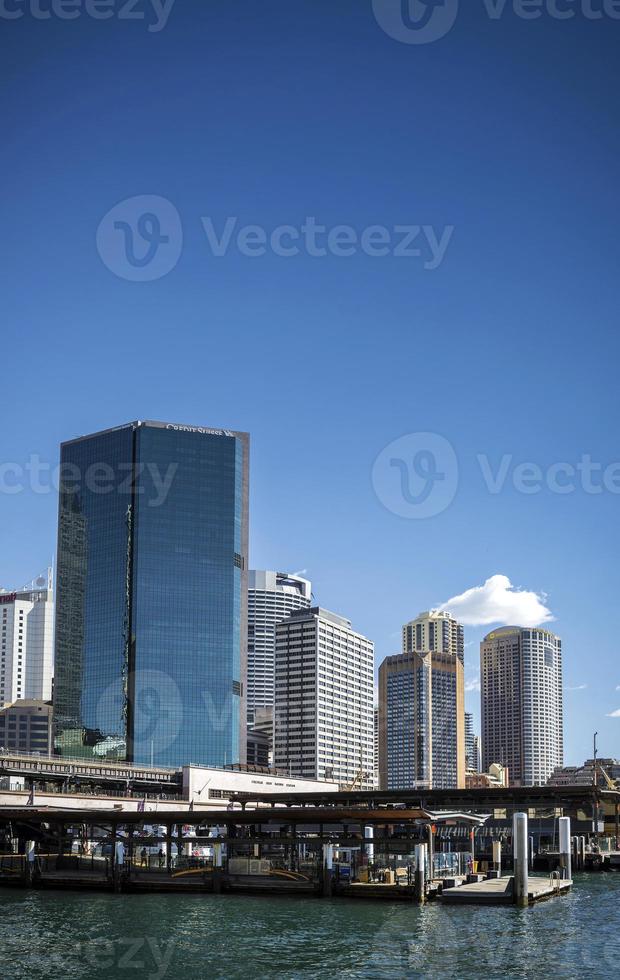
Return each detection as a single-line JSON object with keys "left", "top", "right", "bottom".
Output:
{"left": 0, "top": 571, "right": 54, "bottom": 707}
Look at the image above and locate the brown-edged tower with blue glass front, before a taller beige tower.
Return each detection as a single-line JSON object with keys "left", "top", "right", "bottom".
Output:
{"left": 379, "top": 651, "right": 465, "bottom": 789}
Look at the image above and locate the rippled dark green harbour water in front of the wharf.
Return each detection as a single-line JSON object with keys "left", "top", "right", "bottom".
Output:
{"left": 0, "top": 873, "right": 620, "bottom": 980}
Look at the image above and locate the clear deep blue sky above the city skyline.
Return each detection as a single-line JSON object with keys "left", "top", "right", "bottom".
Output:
{"left": 0, "top": 0, "right": 620, "bottom": 762}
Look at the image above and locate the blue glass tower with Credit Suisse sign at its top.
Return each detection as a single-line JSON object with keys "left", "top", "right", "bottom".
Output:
{"left": 54, "top": 422, "right": 249, "bottom": 766}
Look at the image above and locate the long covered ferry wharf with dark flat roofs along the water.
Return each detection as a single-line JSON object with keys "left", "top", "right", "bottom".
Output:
{"left": 0, "top": 790, "right": 620, "bottom": 905}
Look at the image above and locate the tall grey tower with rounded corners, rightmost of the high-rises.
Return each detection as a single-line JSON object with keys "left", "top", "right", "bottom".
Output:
{"left": 480, "top": 626, "right": 564, "bottom": 786}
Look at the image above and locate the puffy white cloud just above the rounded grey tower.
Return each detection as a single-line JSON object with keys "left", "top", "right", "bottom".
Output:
{"left": 440, "top": 575, "right": 555, "bottom": 626}
